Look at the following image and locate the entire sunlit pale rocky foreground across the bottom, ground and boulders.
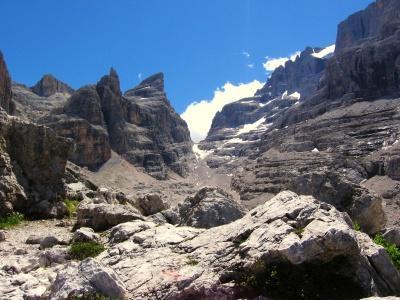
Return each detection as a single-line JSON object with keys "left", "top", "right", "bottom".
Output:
{"left": 0, "top": 192, "right": 400, "bottom": 299}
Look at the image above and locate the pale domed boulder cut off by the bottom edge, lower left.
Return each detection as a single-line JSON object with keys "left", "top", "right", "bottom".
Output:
{"left": 49, "top": 258, "right": 126, "bottom": 300}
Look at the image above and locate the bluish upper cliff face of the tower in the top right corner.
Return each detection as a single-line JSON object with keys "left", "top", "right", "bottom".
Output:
{"left": 336, "top": 0, "right": 400, "bottom": 54}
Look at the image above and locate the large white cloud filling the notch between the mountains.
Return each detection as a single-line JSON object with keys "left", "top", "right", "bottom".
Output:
{"left": 181, "top": 80, "right": 263, "bottom": 142}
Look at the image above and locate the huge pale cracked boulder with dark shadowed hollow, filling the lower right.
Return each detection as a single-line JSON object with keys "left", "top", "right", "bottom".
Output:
{"left": 92, "top": 192, "right": 400, "bottom": 299}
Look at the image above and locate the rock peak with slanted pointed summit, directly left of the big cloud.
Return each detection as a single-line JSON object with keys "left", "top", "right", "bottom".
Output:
{"left": 124, "top": 73, "right": 192, "bottom": 178}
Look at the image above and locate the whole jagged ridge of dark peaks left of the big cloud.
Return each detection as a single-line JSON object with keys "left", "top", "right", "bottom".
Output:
{"left": 13, "top": 69, "right": 192, "bottom": 179}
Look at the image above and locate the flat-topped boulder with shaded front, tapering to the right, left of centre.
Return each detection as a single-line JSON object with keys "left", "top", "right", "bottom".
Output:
{"left": 76, "top": 200, "right": 144, "bottom": 231}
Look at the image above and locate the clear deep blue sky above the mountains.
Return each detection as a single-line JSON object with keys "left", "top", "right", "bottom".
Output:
{"left": 0, "top": 0, "right": 372, "bottom": 113}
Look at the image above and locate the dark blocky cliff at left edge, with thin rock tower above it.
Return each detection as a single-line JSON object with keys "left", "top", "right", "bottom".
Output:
{"left": 0, "top": 55, "right": 70, "bottom": 217}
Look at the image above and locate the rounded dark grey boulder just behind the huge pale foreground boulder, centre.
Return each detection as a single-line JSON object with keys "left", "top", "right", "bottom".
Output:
{"left": 177, "top": 187, "right": 246, "bottom": 228}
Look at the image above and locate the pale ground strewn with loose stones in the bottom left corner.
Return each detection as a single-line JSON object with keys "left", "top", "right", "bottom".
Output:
{"left": 0, "top": 220, "right": 72, "bottom": 300}
